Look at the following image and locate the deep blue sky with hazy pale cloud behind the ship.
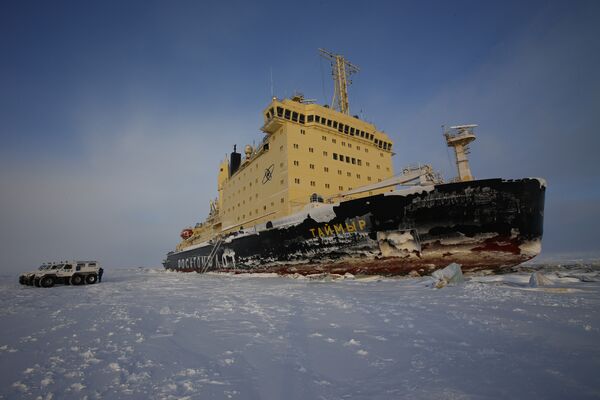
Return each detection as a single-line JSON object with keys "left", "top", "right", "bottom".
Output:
{"left": 0, "top": 1, "right": 600, "bottom": 269}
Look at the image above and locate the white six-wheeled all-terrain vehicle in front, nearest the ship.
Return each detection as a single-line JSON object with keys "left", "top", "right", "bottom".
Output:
{"left": 33, "top": 261, "right": 100, "bottom": 287}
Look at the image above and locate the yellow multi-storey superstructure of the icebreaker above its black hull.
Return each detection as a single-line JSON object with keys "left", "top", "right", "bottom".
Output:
{"left": 178, "top": 50, "right": 394, "bottom": 250}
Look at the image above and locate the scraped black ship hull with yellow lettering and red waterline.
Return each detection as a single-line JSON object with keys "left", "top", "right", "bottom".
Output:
{"left": 164, "top": 178, "right": 545, "bottom": 275}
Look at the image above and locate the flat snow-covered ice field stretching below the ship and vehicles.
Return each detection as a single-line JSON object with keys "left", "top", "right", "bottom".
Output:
{"left": 0, "top": 267, "right": 600, "bottom": 399}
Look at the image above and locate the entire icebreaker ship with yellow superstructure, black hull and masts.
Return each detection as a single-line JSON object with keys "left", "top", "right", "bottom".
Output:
{"left": 164, "top": 49, "right": 545, "bottom": 274}
